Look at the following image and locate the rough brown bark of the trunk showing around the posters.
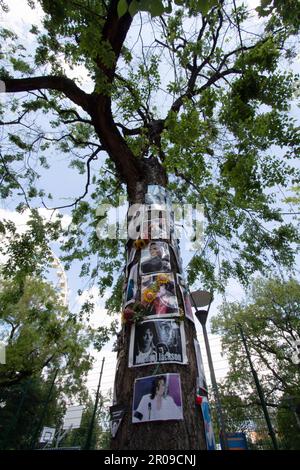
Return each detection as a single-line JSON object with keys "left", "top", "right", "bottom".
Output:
{"left": 111, "top": 158, "right": 206, "bottom": 450}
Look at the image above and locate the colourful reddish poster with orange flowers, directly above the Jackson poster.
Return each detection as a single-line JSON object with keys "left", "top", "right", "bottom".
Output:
{"left": 141, "top": 273, "right": 179, "bottom": 317}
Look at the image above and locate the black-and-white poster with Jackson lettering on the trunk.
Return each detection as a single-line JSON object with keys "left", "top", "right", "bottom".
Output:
{"left": 129, "top": 319, "right": 187, "bottom": 367}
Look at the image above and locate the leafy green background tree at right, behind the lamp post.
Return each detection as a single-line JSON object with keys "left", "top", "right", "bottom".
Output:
{"left": 212, "top": 278, "right": 300, "bottom": 448}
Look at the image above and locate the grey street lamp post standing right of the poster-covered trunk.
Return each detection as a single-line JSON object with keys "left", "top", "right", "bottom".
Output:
{"left": 190, "top": 290, "right": 228, "bottom": 450}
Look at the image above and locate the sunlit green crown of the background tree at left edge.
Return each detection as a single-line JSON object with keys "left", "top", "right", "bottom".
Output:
{"left": 0, "top": 272, "right": 92, "bottom": 394}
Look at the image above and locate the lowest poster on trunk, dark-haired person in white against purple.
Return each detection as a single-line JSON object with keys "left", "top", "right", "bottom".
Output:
{"left": 132, "top": 374, "right": 183, "bottom": 423}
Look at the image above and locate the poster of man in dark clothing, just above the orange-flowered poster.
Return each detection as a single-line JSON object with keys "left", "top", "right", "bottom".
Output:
{"left": 141, "top": 241, "right": 171, "bottom": 274}
